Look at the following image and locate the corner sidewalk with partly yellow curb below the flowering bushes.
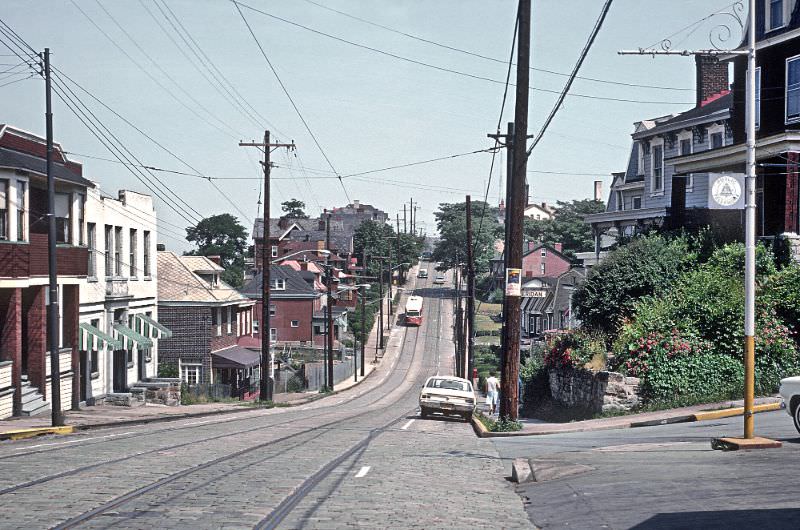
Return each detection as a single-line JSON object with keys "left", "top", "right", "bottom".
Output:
{"left": 473, "top": 397, "right": 781, "bottom": 438}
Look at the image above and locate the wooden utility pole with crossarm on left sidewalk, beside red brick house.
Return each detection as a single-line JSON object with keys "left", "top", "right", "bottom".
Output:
{"left": 239, "top": 131, "right": 295, "bottom": 401}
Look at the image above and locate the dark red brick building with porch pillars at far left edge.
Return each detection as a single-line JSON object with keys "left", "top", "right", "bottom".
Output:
{"left": 0, "top": 125, "right": 94, "bottom": 418}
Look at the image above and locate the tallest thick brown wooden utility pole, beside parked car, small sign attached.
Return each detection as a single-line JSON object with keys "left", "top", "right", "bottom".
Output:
{"left": 500, "top": 0, "right": 531, "bottom": 420}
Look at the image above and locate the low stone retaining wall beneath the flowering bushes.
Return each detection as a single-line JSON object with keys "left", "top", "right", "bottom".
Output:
{"left": 549, "top": 369, "right": 640, "bottom": 414}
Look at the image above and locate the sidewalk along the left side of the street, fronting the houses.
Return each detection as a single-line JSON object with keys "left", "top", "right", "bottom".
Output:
{"left": 0, "top": 268, "right": 412, "bottom": 440}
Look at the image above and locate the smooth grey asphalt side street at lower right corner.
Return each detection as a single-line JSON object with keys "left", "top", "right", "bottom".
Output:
{"left": 494, "top": 411, "right": 800, "bottom": 530}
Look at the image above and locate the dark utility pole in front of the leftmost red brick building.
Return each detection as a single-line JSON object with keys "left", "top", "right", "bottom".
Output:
{"left": 43, "top": 48, "right": 64, "bottom": 427}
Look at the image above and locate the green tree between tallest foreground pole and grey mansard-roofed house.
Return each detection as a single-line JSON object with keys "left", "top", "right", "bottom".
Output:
{"left": 525, "top": 199, "right": 605, "bottom": 258}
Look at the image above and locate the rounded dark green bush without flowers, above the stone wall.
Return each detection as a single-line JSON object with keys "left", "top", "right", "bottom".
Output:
{"left": 574, "top": 235, "right": 697, "bottom": 334}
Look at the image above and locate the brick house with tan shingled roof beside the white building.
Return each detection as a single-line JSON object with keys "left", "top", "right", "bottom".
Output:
{"left": 158, "top": 251, "right": 253, "bottom": 384}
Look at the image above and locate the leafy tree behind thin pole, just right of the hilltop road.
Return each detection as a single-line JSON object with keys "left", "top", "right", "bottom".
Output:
{"left": 433, "top": 201, "right": 502, "bottom": 273}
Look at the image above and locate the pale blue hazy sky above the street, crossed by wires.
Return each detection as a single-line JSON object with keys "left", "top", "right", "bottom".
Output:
{"left": 0, "top": 0, "right": 741, "bottom": 251}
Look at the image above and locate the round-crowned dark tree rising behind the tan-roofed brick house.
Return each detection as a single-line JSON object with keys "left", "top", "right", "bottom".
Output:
{"left": 186, "top": 213, "right": 247, "bottom": 289}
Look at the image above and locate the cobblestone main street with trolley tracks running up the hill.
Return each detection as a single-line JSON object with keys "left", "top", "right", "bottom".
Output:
{"left": 0, "top": 268, "right": 530, "bottom": 529}
